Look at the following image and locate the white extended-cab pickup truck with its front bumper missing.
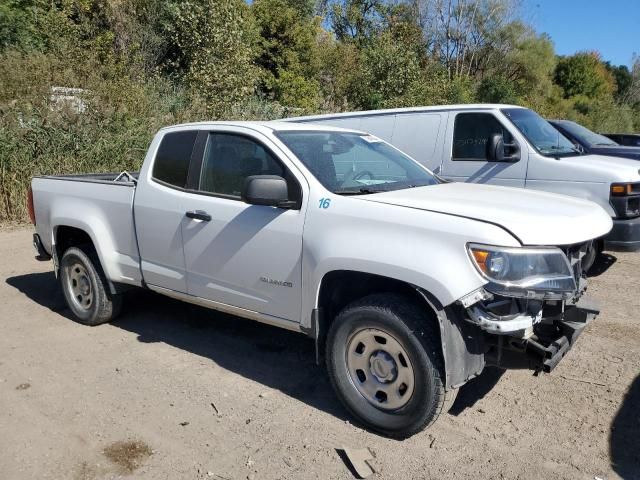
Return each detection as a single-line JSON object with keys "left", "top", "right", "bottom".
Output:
{"left": 28, "top": 122, "right": 612, "bottom": 437}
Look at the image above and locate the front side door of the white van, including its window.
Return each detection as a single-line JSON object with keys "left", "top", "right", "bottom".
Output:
{"left": 439, "top": 111, "right": 528, "bottom": 187}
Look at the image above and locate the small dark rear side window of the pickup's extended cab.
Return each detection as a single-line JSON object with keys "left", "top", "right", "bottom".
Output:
{"left": 151, "top": 130, "right": 198, "bottom": 188}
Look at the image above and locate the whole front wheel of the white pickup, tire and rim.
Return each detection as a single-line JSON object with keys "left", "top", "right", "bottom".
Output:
{"left": 326, "top": 294, "right": 447, "bottom": 438}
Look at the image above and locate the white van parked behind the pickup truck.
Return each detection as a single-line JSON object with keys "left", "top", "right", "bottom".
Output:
{"left": 290, "top": 104, "right": 640, "bottom": 269}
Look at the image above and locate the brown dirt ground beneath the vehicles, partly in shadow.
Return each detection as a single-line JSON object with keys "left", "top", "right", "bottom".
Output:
{"left": 0, "top": 228, "right": 640, "bottom": 480}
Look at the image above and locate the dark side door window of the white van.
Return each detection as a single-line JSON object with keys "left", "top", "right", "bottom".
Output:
{"left": 452, "top": 113, "right": 513, "bottom": 162}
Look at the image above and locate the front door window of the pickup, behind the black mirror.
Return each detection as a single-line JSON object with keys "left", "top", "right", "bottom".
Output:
{"left": 199, "top": 133, "right": 287, "bottom": 199}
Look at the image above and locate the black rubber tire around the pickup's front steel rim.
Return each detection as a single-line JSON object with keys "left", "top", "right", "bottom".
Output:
{"left": 326, "top": 294, "right": 448, "bottom": 438}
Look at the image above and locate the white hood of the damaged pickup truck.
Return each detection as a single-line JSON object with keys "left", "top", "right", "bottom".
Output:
{"left": 355, "top": 183, "right": 613, "bottom": 245}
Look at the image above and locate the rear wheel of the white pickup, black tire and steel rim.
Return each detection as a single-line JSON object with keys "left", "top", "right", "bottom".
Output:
{"left": 60, "top": 247, "right": 122, "bottom": 326}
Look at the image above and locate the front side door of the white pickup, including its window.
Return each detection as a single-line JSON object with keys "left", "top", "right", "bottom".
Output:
{"left": 182, "top": 127, "right": 306, "bottom": 322}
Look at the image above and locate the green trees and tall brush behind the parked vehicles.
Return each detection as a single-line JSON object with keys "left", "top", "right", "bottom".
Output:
{"left": 0, "top": 0, "right": 640, "bottom": 221}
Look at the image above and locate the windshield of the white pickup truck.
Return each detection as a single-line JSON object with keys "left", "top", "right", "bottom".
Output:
{"left": 276, "top": 130, "right": 440, "bottom": 195}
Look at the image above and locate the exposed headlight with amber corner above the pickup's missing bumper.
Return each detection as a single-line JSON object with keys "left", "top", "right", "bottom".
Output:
{"left": 468, "top": 244, "right": 577, "bottom": 299}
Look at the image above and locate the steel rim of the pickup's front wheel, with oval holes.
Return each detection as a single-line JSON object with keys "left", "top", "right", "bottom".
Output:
{"left": 345, "top": 328, "right": 415, "bottom": 410}
